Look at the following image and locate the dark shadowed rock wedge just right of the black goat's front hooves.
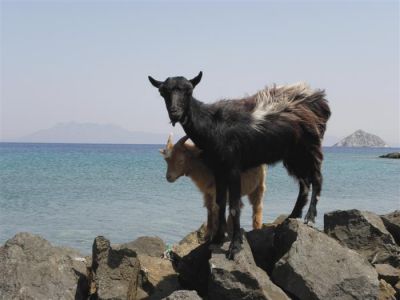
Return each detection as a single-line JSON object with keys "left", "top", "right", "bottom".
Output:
{"left": 246, "top": 225, "right": 275, "bottom": 274}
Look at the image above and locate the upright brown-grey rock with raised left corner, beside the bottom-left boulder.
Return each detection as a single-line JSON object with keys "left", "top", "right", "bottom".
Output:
{"left": 92, "top": 236, "right": 140, "bottom": 300}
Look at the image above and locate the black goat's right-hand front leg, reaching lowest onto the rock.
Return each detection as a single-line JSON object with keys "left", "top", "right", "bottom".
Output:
{"left": 227, "top": 169, "right": 243, "bottom": 259}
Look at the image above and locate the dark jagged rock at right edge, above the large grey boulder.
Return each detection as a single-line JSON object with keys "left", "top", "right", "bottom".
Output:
{"left": 324, "top": 209, "right": 400, "bottom": 267}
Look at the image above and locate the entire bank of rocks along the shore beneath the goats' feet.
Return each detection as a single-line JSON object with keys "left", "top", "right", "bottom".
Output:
{"left": 0, "top": 210, "right": 400, "bottom": 300}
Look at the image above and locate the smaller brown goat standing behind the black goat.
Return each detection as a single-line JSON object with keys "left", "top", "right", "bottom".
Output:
{"left": 160, "top": 135, "right": 266, "bottom": 237}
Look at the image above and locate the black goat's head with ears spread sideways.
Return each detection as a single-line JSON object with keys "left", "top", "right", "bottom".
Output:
{"left": 149, "top": 72, "right": 203, "bottom": 126}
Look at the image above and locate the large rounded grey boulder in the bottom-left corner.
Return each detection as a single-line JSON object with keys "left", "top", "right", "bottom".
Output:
{"left": 0, "top": 233, "right": 88, "bottom": 299}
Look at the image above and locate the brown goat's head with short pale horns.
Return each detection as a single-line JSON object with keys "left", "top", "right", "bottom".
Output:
{"left": 160, "top": 135, "right": 190, "bottom": 182}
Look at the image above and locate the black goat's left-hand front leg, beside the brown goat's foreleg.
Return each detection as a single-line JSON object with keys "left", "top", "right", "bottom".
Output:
{"left": 211, "top": 173, "right": 227, "bottom": 244}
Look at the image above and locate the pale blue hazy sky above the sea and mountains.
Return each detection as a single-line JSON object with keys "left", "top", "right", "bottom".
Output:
{"left": 1, "top": 1, "right": 400, "bottom": 145}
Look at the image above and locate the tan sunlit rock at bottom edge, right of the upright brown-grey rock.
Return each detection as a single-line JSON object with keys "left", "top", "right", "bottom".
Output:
{"left": 138, "top": 255, "right": 180, "bottom": 300}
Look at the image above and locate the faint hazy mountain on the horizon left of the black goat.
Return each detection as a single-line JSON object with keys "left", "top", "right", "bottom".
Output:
{"left": 8, "top": 122, "right": 168, "bottom": 144}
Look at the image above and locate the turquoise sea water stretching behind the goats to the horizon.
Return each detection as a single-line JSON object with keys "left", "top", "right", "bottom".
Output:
{"left": 0, "top": 143, "right": 400, "bottom": 253}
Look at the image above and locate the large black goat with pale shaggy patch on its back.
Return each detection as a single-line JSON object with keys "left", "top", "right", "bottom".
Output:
{"left": 149, "top": 72, "right": 330, "bottom": 258}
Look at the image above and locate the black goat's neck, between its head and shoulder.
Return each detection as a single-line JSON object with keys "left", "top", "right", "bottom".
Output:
{"left": 181, "top": 97, "right": 213, "bottom": 149}
